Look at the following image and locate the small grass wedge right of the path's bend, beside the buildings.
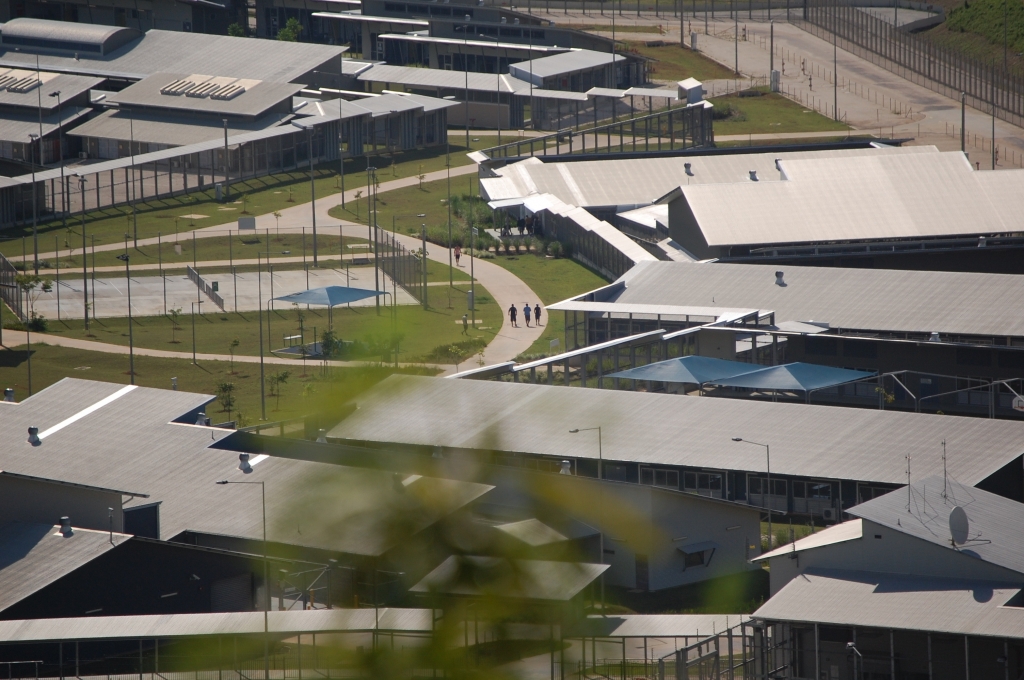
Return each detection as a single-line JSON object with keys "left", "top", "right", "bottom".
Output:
{"left": 492, "top": 255, "right": 608, "bottom": 358}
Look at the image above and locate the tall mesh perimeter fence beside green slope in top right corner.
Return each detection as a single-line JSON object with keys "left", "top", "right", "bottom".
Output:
{"left": 794, "top": 0, "right": 1024, "bottom": 125}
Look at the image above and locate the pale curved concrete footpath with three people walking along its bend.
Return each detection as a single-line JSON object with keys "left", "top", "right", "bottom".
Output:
{"left": 4, "top": 160, "right": 543, "bottom": 372}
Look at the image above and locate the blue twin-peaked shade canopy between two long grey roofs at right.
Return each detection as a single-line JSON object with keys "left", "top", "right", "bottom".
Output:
{"left": 605, "top": 355, "right": 874, "bottom": 394}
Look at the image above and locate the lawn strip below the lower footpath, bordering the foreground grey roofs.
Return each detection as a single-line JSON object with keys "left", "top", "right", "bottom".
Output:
{"left": 0, "top": 342, "right": 435, "bottom": 425}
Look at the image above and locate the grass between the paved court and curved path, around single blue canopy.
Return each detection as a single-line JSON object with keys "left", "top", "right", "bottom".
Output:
{"left": 40, "top": 280, "right": 502, "bottom": 362}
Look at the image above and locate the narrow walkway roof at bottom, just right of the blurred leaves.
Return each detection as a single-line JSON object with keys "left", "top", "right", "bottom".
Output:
{"left": 569, "top": 613, "right": 751, "bottom": 638}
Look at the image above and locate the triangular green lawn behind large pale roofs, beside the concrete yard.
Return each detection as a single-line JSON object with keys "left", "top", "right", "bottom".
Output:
{"left": 710, "top": 93, "right": 850, "bottom": 137}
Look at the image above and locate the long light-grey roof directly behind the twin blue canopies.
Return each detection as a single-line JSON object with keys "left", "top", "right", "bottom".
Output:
{"left": 559, "top": 262, "right": 1024, "bottom": 338}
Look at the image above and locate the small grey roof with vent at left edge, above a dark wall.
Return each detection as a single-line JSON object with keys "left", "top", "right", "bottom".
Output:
{"left": 0, "top": 522, "right": 129, "bottom": 611}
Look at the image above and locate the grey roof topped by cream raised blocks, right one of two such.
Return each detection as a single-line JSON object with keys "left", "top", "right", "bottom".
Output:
{"left": 106, "top": 74, "right": 302, "bottom": 122}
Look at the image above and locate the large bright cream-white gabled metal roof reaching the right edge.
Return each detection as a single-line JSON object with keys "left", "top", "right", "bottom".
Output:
{"left": 670, "top": 152, "right": 1024, "bottom": 246}
